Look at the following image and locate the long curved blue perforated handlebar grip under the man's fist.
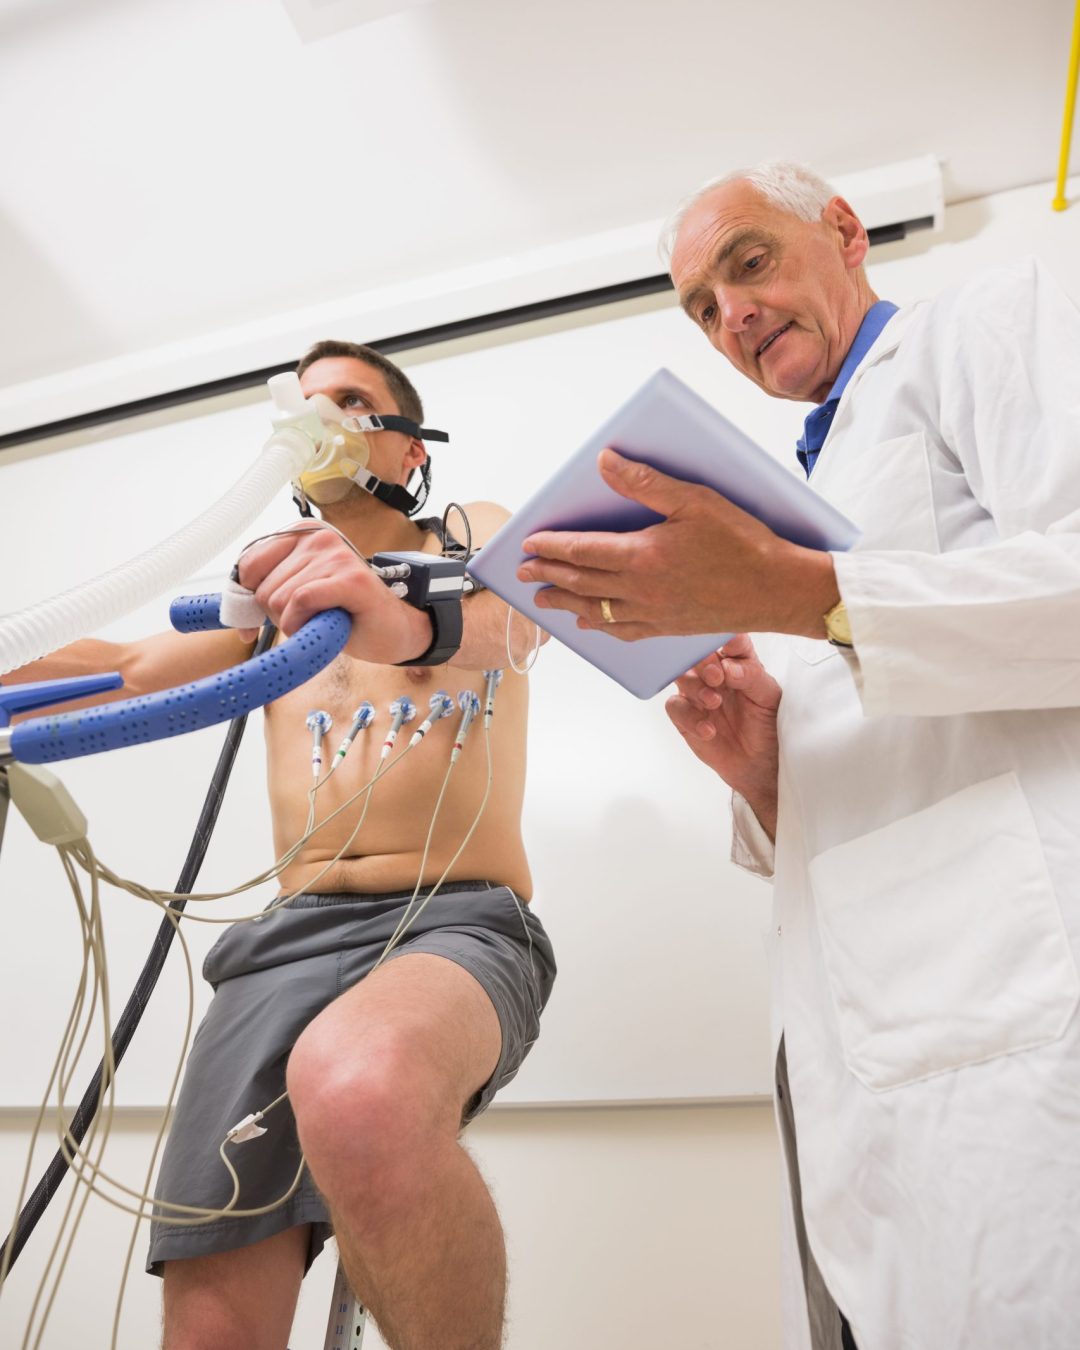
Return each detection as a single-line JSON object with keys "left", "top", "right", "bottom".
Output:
{"left": 11, "top": 609, "right": 352, "bottom": 764}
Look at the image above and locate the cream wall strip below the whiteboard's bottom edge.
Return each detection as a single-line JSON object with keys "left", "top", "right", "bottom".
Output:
{"left": 0, "top": 1106, "right": 779, "bottom": 1350}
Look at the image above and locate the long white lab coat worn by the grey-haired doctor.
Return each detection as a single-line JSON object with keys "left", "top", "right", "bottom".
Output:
{"left": 733, "top": 261, "right": 1080, "bottom": 1350}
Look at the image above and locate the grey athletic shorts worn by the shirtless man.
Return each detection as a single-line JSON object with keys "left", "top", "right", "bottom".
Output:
{"left": 146, "top": 882, "right": 555, "bottom": 1274}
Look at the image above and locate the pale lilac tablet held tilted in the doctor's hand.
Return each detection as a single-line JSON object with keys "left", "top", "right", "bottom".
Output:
{"left": 468, "top": 370, "right": 859, "bottom": 698}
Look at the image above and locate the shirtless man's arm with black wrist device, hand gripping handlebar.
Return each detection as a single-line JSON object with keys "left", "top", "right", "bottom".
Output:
{"left": 239, "top": 502, "right": 547, "bottom": 670}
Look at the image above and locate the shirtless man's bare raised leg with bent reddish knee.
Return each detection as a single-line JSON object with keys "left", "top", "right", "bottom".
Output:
{"left": 288, "top": 953, "right": 506, "bottom": 1350}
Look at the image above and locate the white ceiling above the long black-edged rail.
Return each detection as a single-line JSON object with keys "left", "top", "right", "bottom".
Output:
{"left": 0, "top": 0, "right": 1080, "bottom": 386}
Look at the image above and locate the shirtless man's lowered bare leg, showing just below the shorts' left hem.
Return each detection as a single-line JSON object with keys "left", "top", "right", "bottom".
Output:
{"left": 165, "top": 1224, "right": 308, "bottom": 1350}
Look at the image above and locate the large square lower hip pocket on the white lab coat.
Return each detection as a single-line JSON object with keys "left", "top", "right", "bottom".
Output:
{"left": 810, "top": 774, "right": 1080, "bottom": 1092}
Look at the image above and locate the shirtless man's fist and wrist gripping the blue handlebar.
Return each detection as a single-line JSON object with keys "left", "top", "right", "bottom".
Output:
{"left": 239, "top": 521, "right": 432, "bottom": 666}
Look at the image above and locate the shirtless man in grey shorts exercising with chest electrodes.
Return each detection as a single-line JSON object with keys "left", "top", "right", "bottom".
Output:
{"left": 9, "top": 343, "right": 555, "bottom": 1350}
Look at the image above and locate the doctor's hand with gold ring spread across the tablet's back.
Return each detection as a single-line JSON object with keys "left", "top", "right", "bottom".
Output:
{"left": 517, "top": 450, "right": 840, "bottom": 641}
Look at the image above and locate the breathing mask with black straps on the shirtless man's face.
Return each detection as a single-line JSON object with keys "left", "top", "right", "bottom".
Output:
{"left": 293, "top": 394, "right": 450, "bottom": 516}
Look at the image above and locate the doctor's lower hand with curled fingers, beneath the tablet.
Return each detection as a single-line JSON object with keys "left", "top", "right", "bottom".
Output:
{"left": 666, "top": 633, "right": 782, "bottom": 838}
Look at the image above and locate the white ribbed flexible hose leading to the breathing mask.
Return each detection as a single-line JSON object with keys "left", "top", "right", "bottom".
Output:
{"left": 0, "top": 427, "right": 316, "bottom": 675}
